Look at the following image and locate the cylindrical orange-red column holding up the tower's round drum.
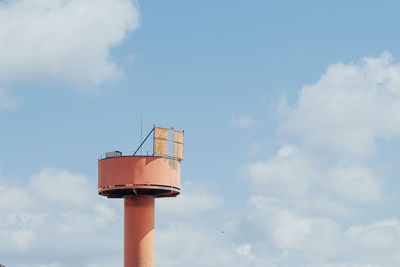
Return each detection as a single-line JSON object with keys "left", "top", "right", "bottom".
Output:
{"left": 124, "top": 195, "right": 154, "bottom": 267}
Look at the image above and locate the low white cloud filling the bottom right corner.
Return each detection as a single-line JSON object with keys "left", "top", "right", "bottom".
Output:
{"left": 227, "top": 195, "right": 400, "bottom": 267}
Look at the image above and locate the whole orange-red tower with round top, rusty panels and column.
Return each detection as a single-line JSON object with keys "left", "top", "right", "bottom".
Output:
{"left": 98, "top": 127, "right": 184, "bottom": 267}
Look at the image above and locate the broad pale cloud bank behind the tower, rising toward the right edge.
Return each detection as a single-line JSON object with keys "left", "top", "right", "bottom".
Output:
{"left": 0, "top": 52, "right": 400, "bottom": 267}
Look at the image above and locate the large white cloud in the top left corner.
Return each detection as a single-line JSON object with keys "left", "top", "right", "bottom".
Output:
{"left": 0, "top": 0, "right": 139, "bottom": 84}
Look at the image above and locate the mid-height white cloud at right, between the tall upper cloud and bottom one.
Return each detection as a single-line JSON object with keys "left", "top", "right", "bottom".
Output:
{"left": 248, "top": 145, "right": 383, "bottom": 211}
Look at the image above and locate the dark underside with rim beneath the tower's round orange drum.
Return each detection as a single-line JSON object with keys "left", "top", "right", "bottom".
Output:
{"left": 99, "top": 184, "right": 181, "bottom": 198}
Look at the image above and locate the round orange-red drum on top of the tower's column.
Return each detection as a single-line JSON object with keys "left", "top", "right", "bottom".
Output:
{"left": 98, "top": 156, "right": 180, "bottom": 198}
